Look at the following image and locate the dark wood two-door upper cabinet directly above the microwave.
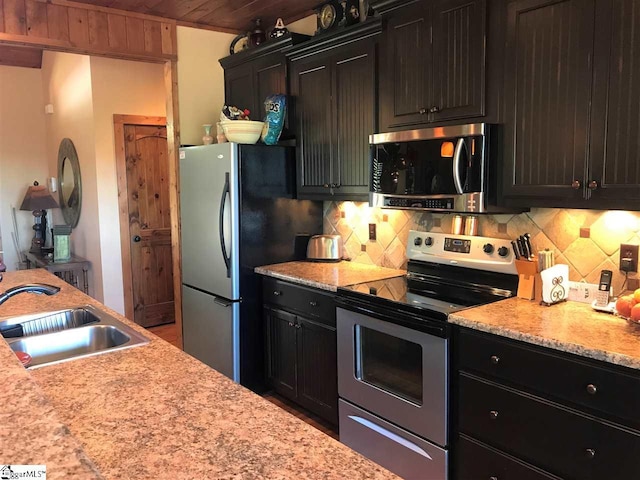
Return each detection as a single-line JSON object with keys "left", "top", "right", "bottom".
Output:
{"left": 379, "top": 0, "right": 486, "bottom": 130}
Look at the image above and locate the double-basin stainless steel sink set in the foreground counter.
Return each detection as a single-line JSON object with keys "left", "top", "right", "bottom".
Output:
{"left": 0, "top": 305, "right": 149, "bottom": 368}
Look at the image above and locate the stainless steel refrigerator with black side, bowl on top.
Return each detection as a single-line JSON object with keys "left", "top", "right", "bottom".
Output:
{"left": 180, "top": 143, "right": 322, "bottom": 391}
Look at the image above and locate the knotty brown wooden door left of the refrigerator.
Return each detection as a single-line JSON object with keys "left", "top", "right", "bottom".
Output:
{"left": 119, "top": 125, "right": 175, "bottom": 327}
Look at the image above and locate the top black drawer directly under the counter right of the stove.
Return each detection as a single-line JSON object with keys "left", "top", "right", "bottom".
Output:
{"left": 458, "top": 330, "right": 640, "bottom": 428}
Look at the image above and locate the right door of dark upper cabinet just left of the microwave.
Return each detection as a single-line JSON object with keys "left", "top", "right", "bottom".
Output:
{"left": 332, "top": 42, "right": 376, "bottom": 200}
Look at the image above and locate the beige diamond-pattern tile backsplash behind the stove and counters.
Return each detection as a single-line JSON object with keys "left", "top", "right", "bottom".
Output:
{"left": 324, "top": 202, "right": 640, "bottom": 294}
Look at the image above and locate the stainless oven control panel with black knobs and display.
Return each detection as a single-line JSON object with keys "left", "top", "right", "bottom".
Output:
{"left": 407, "top": 230, "right": 516, "bottom": 274}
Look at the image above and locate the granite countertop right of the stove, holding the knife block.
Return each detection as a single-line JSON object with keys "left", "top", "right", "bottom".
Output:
{"left": 449, "top": 298, "right": 640, "bottom": 369}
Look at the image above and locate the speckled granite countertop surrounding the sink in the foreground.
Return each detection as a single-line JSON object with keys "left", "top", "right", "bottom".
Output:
{"left": 0, "top": 270, "right": 397, "bottom": 479}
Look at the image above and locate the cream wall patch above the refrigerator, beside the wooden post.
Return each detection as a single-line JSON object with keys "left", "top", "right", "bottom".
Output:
{"left": 177, "top": 27, "right": 235, "bottom": 145}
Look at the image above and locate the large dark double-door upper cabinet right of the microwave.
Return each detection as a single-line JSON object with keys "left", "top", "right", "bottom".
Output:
{"left": 504, "top": 0, "right": 640, "bottom": 209}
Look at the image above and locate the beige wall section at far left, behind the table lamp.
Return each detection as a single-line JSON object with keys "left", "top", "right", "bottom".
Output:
{"left": 0, "top": 66, "right": 49, "bottom": 270}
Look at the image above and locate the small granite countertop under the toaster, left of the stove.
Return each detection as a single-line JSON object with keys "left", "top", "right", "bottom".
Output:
{"left": 255, "top": 261, "right": 407, "bottom": 292}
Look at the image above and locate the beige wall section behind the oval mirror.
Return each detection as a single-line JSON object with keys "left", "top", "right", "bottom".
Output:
{"left": 42, "top": 52, "right": 103, "bottom": 301}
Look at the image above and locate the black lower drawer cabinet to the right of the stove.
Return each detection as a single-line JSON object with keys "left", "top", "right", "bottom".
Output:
{"left": 454, "top": 328, "right": 640, "bottom": 480}
